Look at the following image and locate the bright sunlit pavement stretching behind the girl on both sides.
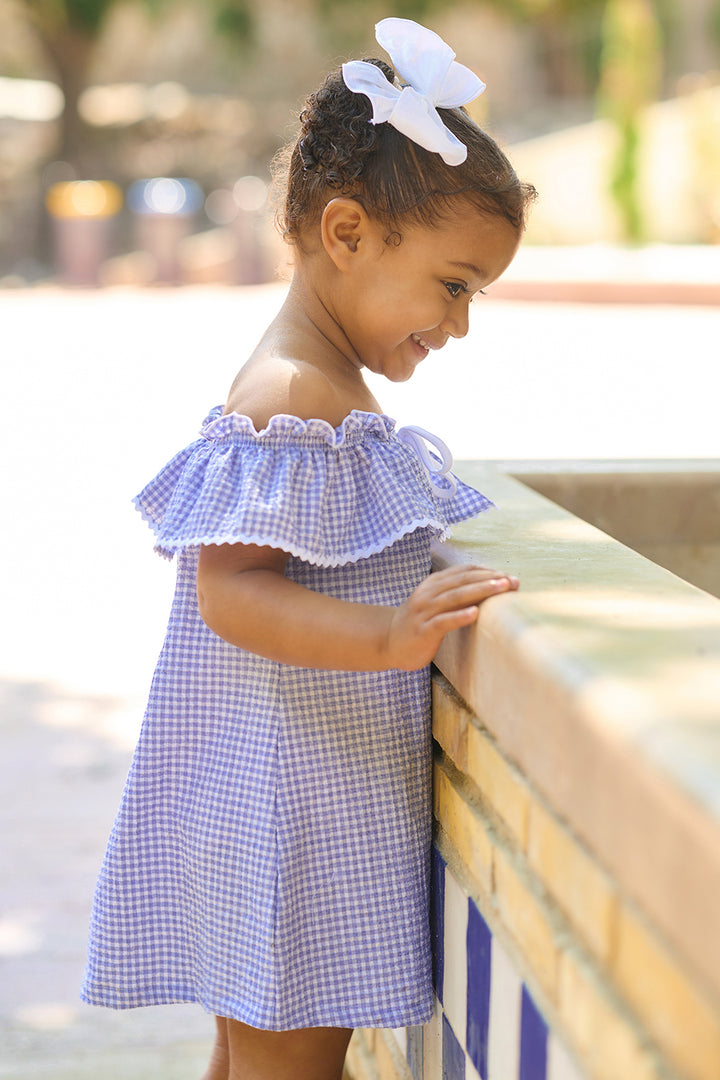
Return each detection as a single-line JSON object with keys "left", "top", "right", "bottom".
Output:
{"left": 0, "top": 265, "right": 720, "bottom": 1080}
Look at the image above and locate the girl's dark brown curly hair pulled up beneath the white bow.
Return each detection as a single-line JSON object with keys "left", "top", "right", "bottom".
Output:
{"left": 275, "top": 59, "right": 536, "bottom": 243}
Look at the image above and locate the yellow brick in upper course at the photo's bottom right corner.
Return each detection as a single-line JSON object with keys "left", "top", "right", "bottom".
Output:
{"left": 613, "top": 906, "right": 720, "bottom": 1080}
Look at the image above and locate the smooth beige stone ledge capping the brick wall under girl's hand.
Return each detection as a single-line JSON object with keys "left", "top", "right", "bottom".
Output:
{"left": 436, "top": 462, "right": 720, "bottom": 1000}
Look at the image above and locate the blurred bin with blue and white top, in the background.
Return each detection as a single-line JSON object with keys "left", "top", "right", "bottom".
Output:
{"left": 127, "top": 176, "right": 203, "bottom": 285}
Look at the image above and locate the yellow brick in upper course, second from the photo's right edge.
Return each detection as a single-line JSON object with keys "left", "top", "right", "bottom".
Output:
{"left": 528, "top": 799, "right": 617, "bottom": 962}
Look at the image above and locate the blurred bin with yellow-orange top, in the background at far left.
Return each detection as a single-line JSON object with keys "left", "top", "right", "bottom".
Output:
{"left": 45, "top": 180, "right": 122, "bottom": 285}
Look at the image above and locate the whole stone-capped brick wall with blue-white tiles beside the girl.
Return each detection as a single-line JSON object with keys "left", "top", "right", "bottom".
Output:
{"left": 349, "top": 464, "right": 720, "bottom": 1080}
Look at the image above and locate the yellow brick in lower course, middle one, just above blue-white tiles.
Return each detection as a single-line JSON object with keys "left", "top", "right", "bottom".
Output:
{"left": 494, "top": 848, "right": 558, "bottom": 1000}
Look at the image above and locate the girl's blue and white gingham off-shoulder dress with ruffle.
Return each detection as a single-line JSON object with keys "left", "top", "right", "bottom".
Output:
{"left": 82, "top": 408, "right": 491, "bottom": 1030}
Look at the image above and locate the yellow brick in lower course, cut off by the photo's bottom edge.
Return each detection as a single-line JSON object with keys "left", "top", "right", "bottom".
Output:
{"left": 558, "top": 954, "right": 660, "bottom": 1080}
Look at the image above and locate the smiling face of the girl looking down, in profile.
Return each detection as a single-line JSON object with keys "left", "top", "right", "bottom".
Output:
{"left": 342, "top": 208, "right": 520, "bottom": 382}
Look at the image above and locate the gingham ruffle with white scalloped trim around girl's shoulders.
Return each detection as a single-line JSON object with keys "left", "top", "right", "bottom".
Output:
{"left": 134, "top": 407, "right": 492, "bottom": 567}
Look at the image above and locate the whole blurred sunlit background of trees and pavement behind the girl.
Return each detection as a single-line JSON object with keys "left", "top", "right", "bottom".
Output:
{"left": 0, "top": 0, "right": 720, "bottom": 1080}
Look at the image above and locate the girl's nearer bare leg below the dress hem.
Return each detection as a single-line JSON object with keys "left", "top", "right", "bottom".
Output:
{"left": 227, "top": 1020, "right": 353, "bottom": 1080}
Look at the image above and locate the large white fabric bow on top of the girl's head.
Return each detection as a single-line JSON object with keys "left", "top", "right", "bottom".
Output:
{"left": 342, "top": 18, "right": 485, "bottom": 165}
